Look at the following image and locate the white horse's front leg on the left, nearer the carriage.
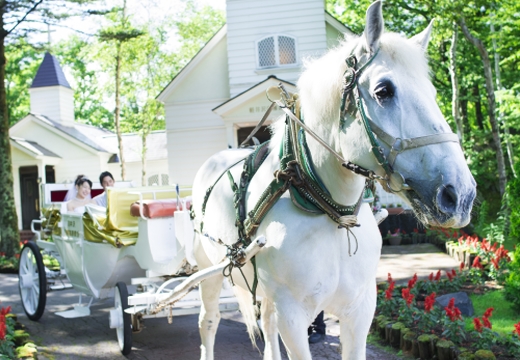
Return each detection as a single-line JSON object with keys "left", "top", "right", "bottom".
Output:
{"left": 276, "top": 298, "right": 312, "bottom": 360}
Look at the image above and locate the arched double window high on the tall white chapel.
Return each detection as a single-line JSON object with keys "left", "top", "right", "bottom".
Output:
{"left": 256, "top": 35, "right": 296, "bottom": 68}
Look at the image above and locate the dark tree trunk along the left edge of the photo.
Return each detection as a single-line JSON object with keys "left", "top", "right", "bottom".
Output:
{"left": 0, "top": 9, "right": 20, "bottom": 257}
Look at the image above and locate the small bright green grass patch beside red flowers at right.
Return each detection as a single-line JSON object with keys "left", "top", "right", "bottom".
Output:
{"left": 466, "top": 290, "right": 520, "bottom": 336}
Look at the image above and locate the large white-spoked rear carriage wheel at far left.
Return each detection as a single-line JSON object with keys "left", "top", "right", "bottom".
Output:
{"left": 18, "top": 241, "right": 47, "bottom": 321}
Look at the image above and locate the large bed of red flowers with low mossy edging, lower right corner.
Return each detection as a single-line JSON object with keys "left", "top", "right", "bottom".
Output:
{"left": 373, "top": 258, "right": 520, "bottom": 360}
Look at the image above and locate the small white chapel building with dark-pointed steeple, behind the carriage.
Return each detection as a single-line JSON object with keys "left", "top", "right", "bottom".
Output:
{"left": 9, "top": 53, "right": 170, "bottom": 229}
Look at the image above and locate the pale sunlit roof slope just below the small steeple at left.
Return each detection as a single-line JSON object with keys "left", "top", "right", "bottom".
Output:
{"left": 31, "top": 114, "right": 113, "bottom": 152}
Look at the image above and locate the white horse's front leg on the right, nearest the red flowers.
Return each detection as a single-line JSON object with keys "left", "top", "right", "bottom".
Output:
{"left": 340, "top": 286, "right": 377, "bottom": 360}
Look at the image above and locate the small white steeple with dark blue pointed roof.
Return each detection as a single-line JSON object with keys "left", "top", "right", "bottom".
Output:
{"left": 29, "top": 52, "right": 74, "bottom": 126}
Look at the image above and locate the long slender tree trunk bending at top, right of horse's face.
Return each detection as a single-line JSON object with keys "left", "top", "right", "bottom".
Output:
{"left": 459, "top": 18, "right": 507, "bottom": 196}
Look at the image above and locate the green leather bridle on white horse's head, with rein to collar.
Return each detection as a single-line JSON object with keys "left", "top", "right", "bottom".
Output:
{"left": 267, "top": 49, "right": 459, "bottom": 193}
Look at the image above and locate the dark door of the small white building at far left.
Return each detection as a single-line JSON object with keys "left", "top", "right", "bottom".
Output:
{"left": 20, "top": 166, "right": 40, "bottom": 230}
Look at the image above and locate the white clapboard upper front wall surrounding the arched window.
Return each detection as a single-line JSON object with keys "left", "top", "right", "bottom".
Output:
{"left": 226, "top": 0, "right": 327, "bottom": 97}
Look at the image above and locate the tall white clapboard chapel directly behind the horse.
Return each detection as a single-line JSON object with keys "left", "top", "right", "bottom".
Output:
{"left": 158, "top": 0, "right": 350, "bottom": 185}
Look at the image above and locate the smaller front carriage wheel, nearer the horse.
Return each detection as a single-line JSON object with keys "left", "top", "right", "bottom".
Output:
{"left": 114, "top": 281, "right": 132, "bottom": 355}
